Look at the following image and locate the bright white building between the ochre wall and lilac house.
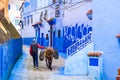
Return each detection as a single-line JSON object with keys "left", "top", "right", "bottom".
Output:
{"left": 8, "top": 0, "right": 23, "bottom": 34}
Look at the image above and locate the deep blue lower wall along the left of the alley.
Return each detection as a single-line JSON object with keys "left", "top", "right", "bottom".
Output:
{"left": 0, "top": 38, "right": 22, "bottom": 80}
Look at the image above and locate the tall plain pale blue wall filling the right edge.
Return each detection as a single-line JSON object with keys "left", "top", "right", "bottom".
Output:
{"left": 93, "top": 0, "right": 120, "bottom": 80}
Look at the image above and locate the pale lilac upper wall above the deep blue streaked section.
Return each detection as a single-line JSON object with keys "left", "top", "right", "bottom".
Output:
{"left": 63, "top": 2, "right": 92, "bottom": 26}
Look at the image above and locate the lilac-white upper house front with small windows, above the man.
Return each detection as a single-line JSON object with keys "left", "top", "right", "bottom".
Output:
{"left": 21, "top": 0, "right": 62, "bottom": 44}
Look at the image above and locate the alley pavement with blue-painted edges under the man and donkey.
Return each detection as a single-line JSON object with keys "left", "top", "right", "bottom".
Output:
{"left": 9, "top": 46, "right": 93, "bottom": 80}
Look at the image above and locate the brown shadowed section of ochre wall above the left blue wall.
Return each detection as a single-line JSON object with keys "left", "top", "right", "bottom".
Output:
{"left": 0, "top": 15, "right": 21, "bottom": 43}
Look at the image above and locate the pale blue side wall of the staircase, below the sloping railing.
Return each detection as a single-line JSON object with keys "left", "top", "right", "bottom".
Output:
{"left": 64, "top": 43, "right": 93, "bottom": 76}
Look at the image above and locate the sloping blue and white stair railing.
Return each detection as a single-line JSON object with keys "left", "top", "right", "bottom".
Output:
{"left": 67, "top": 32, "right": 92, "bottom": 57}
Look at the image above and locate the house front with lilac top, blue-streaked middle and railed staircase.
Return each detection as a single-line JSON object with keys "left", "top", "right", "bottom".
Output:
{"left": 63, "top": 1, "right": 93, "bottom": 76}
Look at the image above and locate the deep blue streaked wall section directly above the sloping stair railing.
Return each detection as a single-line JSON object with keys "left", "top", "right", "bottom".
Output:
{"left": 63, "top": 23, "right": 92, "bottom": 52}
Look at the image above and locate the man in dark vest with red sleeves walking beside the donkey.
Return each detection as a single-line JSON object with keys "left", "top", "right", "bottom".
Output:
{"left": 30, "top": 39, "right": 45, "bottom": 69}
